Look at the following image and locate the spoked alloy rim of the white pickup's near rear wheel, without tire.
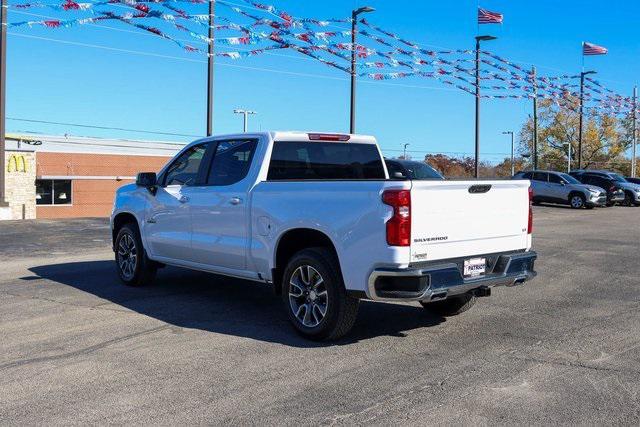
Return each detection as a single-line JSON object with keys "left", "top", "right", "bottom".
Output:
{"left": 289, "top": 265, "right": 329, "bottom": 328}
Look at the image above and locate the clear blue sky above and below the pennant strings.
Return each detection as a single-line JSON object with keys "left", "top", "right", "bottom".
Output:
{"left": 7, "top": 0, "right": 640, "bottom": 161}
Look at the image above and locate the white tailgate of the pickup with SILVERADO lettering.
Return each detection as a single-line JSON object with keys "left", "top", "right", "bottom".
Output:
{"left": 411, "top": 180, "right": 529, "bottom": 262}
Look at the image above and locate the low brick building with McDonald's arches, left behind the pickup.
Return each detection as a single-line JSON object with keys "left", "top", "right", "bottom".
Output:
{"left": 0, "top": 135, "right": 184, "bottom": 219}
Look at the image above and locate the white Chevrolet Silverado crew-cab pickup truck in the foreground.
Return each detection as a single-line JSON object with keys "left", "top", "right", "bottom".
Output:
{"left": 111, "top": 132, "right": 536, "bottom": 340}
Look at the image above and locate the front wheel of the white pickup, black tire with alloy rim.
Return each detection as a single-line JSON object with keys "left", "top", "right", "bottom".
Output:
{"left": 115, "top": 223, "right": 158, "bottom": 286}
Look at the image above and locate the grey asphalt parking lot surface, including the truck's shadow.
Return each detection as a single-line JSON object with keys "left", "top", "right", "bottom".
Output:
{"left": 0, "top": 206, "right": 640, "bottom": 425}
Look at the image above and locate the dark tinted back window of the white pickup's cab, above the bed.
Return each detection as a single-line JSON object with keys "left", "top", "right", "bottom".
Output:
{"left": 267, "top": 141, "right": 385, "bottom": 181}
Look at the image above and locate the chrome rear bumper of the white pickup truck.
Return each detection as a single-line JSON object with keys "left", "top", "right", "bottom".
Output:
{"left": 367, "top": 251, "right": 537, "bottom": 301}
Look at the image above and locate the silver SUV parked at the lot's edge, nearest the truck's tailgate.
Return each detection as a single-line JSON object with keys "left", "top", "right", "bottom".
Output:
{"left": 513, "top": 170, "right": 607, "bottom": 209}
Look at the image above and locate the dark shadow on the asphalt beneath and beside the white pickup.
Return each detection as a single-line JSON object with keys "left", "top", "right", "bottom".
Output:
{"left": 23, "top": 261, "right": 445, "bottom": 347}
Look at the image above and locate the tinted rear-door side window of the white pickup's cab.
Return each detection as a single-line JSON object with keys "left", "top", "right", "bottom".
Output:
{"left": 207, "top": 139, "right": 258, "bottom": 186}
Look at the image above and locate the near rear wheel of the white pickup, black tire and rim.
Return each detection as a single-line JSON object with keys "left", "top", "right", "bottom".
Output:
{"left": 282, "top": 248, "right": 360, "bottom": 341}
